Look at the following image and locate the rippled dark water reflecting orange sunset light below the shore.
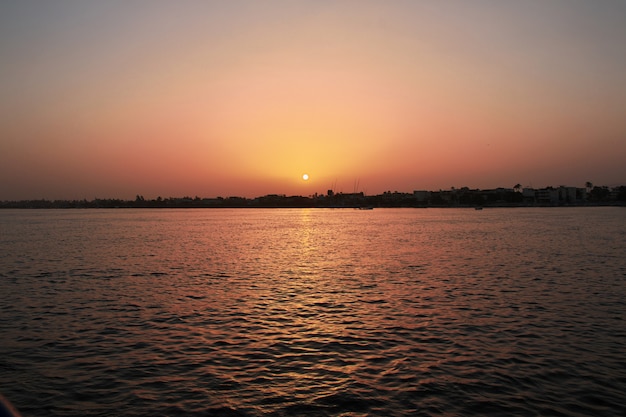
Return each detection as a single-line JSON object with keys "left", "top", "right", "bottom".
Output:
{"left": 0, "top": 208, "right": 626, "bottom": 417}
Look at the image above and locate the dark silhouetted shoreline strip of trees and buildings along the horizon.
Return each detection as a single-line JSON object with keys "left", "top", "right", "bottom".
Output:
{"left": 0, "top": 186, "right": 626, "bottom": 208}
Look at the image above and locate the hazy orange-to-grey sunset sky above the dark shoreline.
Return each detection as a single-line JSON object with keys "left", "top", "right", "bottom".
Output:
{"left": 0, "top": 0, "right": 626, "bottom": 200}
